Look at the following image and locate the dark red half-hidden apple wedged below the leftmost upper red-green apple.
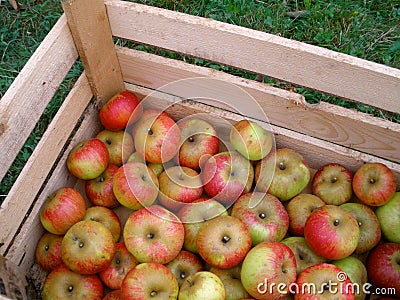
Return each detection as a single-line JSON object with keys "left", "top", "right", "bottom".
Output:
{"left": 85, "top": 164, "right": 120, "bottom": 208}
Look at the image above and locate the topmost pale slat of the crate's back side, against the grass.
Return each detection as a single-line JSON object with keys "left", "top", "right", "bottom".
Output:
{"left": 106, "top": 1, "right": 400, "bottom": 113}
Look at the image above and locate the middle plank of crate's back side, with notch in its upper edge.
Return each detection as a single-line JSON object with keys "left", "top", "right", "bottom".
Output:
{"left": 117, "top": 47, "right": 400, "bottom": 162}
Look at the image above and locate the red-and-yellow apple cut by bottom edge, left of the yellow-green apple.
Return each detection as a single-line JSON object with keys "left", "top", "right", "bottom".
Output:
{"left": 121, "top": 262, "right": 179, "bottom": 300}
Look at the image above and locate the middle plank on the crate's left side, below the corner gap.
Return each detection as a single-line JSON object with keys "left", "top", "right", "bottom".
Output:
{"left": 0, "top": 73, "right": 93, "bottom": 254}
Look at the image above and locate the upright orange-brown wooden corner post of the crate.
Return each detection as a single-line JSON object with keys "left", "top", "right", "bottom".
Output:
{"left": 61, "top": 0, "right": 124, "bottom": 104}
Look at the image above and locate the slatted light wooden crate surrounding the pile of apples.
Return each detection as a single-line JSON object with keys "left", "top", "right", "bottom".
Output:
{"left": 0, "top": 0, "right": 400, "bottom": 294}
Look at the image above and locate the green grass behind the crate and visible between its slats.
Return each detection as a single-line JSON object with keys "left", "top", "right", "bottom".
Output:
{"left": 0, "top": 0, "right": 400, "bottom": 202}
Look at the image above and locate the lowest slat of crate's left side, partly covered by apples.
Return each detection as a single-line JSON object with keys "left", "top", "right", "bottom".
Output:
{"left": 5, "top": 107, "right": 102, "bottom": 271}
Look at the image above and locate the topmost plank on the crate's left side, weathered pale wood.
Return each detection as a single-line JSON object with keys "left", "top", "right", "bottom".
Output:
{"left": 0, "top": 16, "right": 78, "bottom": 180}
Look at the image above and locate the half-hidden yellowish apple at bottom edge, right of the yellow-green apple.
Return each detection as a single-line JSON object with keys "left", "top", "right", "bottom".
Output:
{"left": 210, "top": 264, "right": 250, "bottom": 300}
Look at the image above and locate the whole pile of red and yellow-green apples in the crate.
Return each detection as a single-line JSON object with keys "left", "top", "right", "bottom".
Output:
{"left": 36, "top": 91, "right": 400, "bottom": 300}
